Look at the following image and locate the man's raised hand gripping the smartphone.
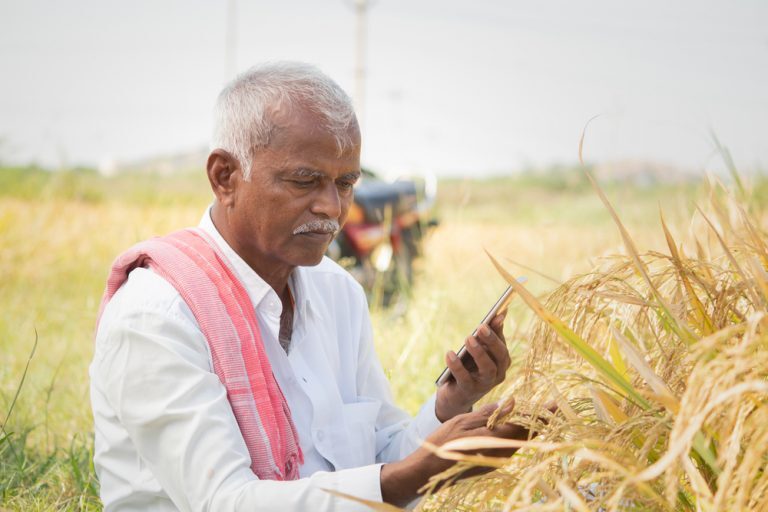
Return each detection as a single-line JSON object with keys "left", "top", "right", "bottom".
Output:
{"left": 435, "top": 310, "right": 510, "bottom": 422}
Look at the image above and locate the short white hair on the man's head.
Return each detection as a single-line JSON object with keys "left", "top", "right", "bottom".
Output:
{"left": 211, "top": 62, "right": 356, "bottom": 180}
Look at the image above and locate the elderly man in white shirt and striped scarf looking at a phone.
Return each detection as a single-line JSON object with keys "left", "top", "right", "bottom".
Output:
{"left": 90, "top": 63, "right": 521, "bottom": 511}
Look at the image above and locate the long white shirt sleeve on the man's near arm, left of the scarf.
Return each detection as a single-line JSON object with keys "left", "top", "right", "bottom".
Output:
{"left": 92, "top": 274, "right": 388, "bottom": 511}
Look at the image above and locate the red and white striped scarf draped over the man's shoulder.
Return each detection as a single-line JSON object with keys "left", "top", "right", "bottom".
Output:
{"left": 99, "top": 228, "right": 304, "bottom": 480}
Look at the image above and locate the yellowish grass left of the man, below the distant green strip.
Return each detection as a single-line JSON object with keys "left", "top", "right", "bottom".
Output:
{"left": 0, "top": 191, "right": 205, "bottom": 512}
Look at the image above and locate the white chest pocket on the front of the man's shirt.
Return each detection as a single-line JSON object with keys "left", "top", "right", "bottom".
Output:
{"left": 337, "top": 400, "right": 381, "bottom": 469}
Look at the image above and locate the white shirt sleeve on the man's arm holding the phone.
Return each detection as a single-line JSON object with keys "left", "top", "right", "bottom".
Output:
{"left": 357, "top": 307, "right": 441, "bottom": 462}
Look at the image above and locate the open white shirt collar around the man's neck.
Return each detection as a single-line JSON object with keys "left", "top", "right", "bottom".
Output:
{"left": 198, "top": 205, "right": 311, "bottom": 317}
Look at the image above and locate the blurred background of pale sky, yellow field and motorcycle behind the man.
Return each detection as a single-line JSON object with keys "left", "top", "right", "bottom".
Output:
{"left": 0, "top": 0, "right": 768, "bottom": 511}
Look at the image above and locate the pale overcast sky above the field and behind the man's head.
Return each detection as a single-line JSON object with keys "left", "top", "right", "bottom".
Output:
{"left": 0, "top": 0, "right": 768, "bottom": 174}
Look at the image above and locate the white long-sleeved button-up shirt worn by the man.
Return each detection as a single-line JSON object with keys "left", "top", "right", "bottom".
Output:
{"left": 90, "top": 212, "right": 440, "bottom": 512}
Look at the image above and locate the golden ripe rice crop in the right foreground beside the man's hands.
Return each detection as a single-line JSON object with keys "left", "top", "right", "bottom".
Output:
{"left": 420, "top": 174, "right": 768, "bottom": 511}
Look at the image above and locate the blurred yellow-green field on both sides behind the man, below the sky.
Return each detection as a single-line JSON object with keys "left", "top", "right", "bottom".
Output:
{"left": 0, "top": 169, "right": 761, "bottom": 511}
